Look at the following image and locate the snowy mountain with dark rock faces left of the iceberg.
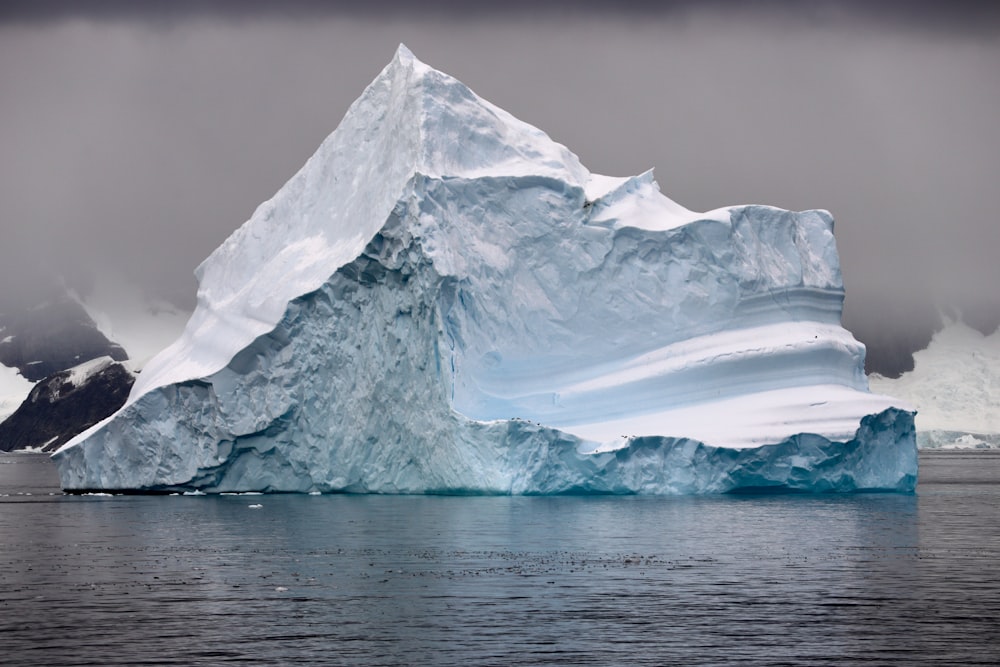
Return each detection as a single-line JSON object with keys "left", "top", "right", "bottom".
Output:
{"left": 0, "top": 275, "right": 186, "bottom": 451}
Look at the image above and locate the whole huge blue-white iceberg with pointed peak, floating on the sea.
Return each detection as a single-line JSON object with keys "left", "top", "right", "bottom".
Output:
{"left": 54, "top": 46, "right": 917, "bottom": 494}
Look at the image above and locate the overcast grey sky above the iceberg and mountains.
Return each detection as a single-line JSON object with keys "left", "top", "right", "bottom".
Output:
{"left": 0, "top": 0, "right": 1000, "bottom": 374}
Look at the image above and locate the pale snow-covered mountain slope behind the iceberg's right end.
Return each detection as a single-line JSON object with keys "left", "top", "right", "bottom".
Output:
{"left": 869, "top": 321, "right": 1000, "bottom": 448}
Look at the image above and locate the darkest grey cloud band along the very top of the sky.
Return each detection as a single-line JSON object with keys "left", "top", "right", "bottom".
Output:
{"left": 0, "top": 0, "right": 1000, "bottom": 36}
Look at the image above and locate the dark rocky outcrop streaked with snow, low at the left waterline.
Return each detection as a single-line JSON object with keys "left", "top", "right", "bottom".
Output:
{"left": 0, "top": 357, "right": 135, "bottom": 451}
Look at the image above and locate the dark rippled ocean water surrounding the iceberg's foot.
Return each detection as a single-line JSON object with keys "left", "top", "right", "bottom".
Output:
{"left": 0, "top": 451, "right": 1000, "bottom": 666}
